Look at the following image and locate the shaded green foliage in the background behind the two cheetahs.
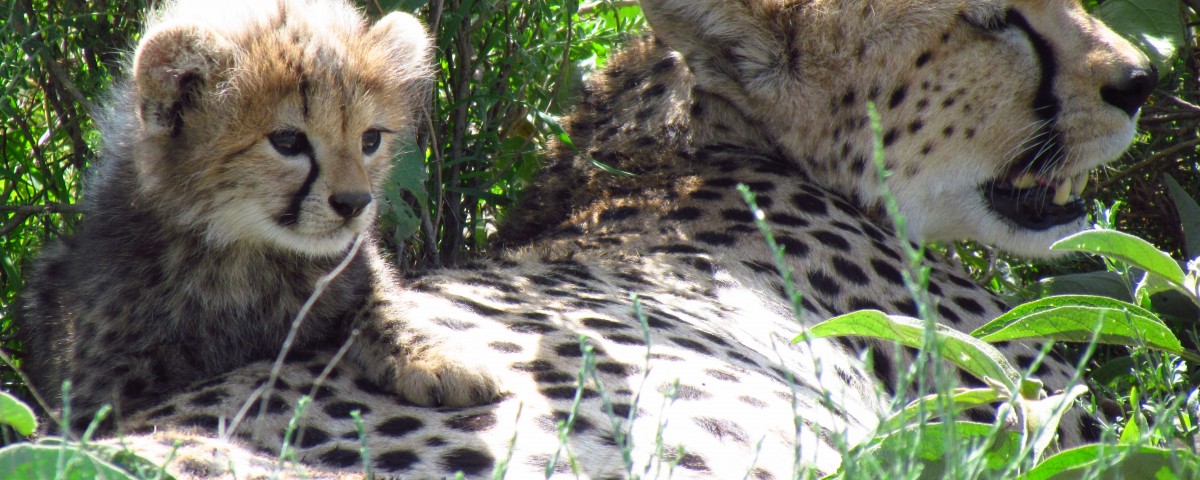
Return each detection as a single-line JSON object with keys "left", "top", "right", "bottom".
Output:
{"left": 0, "top": 0, "right": 1200, "bottom": 415}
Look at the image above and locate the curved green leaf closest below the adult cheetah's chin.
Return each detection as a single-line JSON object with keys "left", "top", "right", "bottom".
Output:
{"left": 1050, "top": 230, "right": 1183, "bottom": 284}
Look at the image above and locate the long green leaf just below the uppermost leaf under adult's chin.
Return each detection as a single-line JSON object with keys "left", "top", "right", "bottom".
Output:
{"left": 971, "top": 295, "right": 1184, "bottom": 354}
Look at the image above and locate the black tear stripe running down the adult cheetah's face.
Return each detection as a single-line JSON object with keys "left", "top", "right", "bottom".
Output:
{"left": 1004, "top": 8, "right": 1066, "bottom": 172}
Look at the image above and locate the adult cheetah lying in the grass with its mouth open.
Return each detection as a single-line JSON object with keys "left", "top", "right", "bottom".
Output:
{"left": 30, "top": 0, "right": 1156, "bottom": 479}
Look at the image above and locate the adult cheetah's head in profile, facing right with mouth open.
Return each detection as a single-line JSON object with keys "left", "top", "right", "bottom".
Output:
{"left": 643, "top": 0, "right": 1157, "bottom": 256}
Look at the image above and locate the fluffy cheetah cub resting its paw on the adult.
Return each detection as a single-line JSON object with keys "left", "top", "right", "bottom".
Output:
{"left": 18, "top": 0, "right": 498, "bottom": 428}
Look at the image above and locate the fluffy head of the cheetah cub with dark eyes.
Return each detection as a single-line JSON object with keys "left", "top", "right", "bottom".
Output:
{"left": 124, "top": 0, "right": 428, "bottom": 256}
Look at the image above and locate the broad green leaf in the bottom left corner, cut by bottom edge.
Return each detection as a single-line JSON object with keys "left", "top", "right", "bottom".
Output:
{"left": 0, "top": 443, "right": 133, "bottom": 480}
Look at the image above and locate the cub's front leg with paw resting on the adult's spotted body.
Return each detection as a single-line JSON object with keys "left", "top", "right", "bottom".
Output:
{"left": 350, "top": 247, "right": 500, "bottom": 407}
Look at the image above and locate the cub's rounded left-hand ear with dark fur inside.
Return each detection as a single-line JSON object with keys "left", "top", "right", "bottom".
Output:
{"left": 133, "top": 24, "right": 233, "bottom": 137}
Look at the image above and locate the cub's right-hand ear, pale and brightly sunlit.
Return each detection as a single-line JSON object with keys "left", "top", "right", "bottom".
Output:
{"left": 367, "top": 12, "right": 433, "bottom": 96}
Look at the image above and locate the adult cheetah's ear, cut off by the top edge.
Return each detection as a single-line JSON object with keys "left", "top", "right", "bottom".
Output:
{"left": 642, "top": 0, "right": 802, "bottom": 94}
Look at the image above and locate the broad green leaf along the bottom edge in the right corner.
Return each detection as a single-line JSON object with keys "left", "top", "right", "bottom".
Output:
{"left": 1024, "top": 444, "right": 1200, "bottom": 480}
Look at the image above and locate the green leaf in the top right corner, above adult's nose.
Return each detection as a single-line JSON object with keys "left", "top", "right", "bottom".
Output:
{"left": 1092, "top": 0, "right": 1186, "bottom": 69}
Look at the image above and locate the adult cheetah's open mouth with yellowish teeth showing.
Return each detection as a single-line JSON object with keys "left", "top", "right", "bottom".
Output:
{"left": 979, "top": 169, "right": 1087, "bottom": 230}
